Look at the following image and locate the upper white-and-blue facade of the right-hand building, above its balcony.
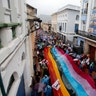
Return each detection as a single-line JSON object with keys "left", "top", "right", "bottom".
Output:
{"left": 79, "top": 0, "right": 96, "bottom": 32}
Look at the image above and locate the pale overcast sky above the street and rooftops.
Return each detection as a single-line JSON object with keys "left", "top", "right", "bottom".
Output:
{"left": 26, "top": 0, "right": 80, "bottom": 15}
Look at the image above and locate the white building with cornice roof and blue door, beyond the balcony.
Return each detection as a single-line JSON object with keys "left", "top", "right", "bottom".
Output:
{"left": 57, "top": 5, "right": 80, "bottom": 41}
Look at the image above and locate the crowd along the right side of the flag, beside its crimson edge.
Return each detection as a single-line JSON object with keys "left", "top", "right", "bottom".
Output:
{"left": 56, "top": 40, "right": 96, "bottom": 82}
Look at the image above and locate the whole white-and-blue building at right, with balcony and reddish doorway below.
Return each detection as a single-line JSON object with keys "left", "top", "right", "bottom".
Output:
{"left": 75, "top": 0, "right": 96, "bottom": 61}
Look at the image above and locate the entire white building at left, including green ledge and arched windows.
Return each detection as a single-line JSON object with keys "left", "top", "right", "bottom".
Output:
{"left": 0, "top": 0, "right": 32, "bottom": 96}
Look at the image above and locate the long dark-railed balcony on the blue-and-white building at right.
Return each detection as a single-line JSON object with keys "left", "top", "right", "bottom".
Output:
{"left": 77, "top": 30, "right": 96, "bottom": 41}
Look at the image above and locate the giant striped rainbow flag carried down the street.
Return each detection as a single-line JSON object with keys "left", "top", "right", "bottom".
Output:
{"left": 44, "top": 47, "right": 96, "bottom": 96}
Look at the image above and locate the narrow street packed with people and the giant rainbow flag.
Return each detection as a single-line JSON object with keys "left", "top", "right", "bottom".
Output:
{"left": 31, "top": 30, "right": 96, "bottom": 96}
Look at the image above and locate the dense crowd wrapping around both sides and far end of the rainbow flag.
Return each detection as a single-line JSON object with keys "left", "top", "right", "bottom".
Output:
{"left": 30, "top": 30, "right": 96, "bottom": 96}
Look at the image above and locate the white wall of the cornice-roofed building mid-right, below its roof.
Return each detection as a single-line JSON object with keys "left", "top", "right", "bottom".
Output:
{"left": 57, "top": 10, "right": 79, "bottom": 33}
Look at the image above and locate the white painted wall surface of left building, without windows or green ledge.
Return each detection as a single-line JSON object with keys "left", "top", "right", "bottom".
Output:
{"left": 0, "top": 0, "right": 33, "bottom": 96}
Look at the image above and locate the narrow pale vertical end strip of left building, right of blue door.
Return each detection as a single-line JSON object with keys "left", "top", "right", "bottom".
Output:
{"left": 24, "top": 37, "right": 32, "bottom": 96}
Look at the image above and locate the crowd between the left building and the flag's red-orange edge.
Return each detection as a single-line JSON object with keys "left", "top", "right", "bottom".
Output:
{"left": 30, "top": 31, "right": 53, "bottom": 96}
